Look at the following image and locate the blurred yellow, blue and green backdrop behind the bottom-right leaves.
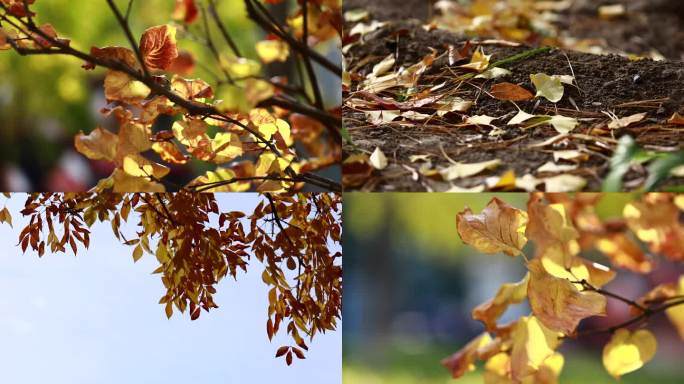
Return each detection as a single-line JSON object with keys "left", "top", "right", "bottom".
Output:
{"left": 343, "top": 193, "right": 684, "bottom": 384}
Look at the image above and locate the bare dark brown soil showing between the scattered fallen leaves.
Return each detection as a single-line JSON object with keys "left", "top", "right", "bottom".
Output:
{"left": 343, "top": 0, "right": 684, "bottom": 191}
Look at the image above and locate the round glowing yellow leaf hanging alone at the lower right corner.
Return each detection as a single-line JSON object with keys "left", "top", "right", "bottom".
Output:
{"left": 603, "top": 328, "right": 658, "bottom": 379}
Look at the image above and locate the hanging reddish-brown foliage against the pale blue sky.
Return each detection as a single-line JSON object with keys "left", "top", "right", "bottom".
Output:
{"left": 0, "top": 192, "right": 342, "bottom": 365}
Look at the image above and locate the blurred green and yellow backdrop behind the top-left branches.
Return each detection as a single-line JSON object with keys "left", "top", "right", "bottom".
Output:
{"left": 0, "top": 0, "right": 341, "bottom": 191}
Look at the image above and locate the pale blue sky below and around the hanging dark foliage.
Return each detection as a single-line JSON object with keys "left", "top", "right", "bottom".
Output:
{"left": 0, "top": 194, "right": 342, "bottom": 384}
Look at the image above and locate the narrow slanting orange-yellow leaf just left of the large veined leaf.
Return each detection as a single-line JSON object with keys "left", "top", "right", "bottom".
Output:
{"left": 472, "top": 274, "right": 529, "bottom": 332}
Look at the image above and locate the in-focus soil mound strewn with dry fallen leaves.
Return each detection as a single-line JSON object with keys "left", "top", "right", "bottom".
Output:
{"left": 343, "top": 1, "right": 684, "bottom": 191}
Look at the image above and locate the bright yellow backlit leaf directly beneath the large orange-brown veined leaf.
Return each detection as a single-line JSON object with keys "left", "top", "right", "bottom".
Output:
{"left": 511, "top": 316, "right": 560, "bottom": 381}
